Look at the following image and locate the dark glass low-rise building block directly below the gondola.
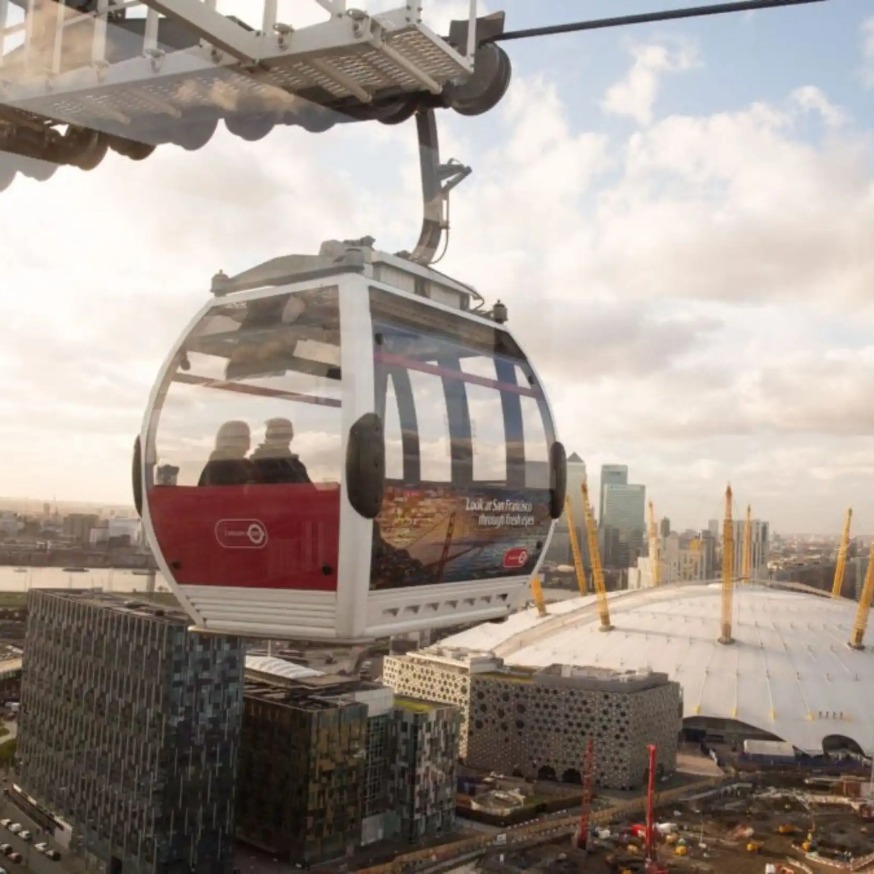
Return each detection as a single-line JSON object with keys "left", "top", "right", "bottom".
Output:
{"left": 237, "top": 657, "right": 460, "bottom": 865}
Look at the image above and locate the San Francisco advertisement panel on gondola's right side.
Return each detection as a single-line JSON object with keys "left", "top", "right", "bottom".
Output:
{"left": 370, "top": 485, "right": 552, "bottom": 589}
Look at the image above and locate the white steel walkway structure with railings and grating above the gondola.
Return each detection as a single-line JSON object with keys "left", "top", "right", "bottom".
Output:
{"left": 0, "top": 0, "right": 473, "bottom": 134}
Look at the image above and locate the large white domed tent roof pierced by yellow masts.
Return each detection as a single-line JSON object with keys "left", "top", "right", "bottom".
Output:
{"left": 441, "top": 583, "right": 874, "bottom": 756}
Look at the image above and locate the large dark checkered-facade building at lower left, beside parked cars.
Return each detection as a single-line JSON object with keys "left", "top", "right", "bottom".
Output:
{"left": 16, "top": 589, "right": 243, "bottom": 874}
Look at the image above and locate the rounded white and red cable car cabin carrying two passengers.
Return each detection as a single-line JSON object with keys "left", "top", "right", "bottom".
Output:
{"left": 134, "top": 232, "right": 565, "bottom": 641}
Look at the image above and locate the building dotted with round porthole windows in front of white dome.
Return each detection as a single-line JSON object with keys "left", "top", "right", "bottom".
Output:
{"left": 383, "top": 646, "right": 682, "bottom": 789}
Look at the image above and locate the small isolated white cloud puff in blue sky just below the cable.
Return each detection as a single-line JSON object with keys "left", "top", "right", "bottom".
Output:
{"left": 601, "top": 43, "right": 700, "bottom": 126}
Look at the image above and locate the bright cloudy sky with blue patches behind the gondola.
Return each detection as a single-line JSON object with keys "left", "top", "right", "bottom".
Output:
{"left": 0, "top": 0, "right": 874, "bottom": 534}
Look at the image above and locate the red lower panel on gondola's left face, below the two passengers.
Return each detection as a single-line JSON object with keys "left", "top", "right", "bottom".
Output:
{"left": 148, "top": 484, "right": 340, "bottom": 591}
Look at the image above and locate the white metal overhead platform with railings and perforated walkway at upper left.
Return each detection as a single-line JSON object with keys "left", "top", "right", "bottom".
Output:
{"left": 0, "top": 0, "right": 476, "bottom": 135}
